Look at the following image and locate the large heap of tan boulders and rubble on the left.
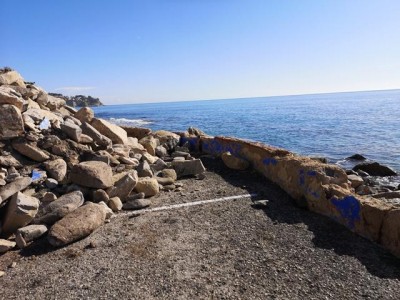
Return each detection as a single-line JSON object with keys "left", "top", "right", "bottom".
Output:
{"left": 0, "top": 69, "right": 205, "bottom": 253}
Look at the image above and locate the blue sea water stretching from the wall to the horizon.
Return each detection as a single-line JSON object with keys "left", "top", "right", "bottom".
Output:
{"left": 94, "top": 90, "right": 400, "bottom": 171}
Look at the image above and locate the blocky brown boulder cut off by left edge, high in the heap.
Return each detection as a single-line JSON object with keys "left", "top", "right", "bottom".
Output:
{"left": 0, "top": 104, "right": 24, "bottom": 140}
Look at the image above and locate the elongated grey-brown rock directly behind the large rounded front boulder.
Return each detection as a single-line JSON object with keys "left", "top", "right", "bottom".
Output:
{"left": 34, "top": 191, "right": 84, "bottom": 224}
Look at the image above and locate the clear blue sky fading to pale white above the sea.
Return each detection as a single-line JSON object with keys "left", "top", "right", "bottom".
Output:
{"left": 0, "top": 0, "right": 400, "bottom": 104}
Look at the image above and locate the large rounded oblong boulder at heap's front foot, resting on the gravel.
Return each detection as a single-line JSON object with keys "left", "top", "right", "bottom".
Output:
{"left": 47, "top": 203, "right": 106, "bottom": 247}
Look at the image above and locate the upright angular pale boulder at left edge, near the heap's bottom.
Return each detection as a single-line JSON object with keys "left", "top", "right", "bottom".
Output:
{"left": 1, "top": 192, "right": 39, "bottom": 237}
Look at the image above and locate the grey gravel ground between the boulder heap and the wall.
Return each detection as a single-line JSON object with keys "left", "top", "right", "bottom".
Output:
{"left": 0, "top": 158, "right": 400, "bottom": 299}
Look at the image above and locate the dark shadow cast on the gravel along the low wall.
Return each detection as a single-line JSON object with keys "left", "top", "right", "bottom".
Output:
{"left": 202, "top": 157, "right": 400, "bottom": 279}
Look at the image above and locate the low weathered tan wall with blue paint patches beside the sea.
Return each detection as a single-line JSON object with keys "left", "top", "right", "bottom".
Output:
{"left": 181, "top": 136, "right": 400, "bottom": 257}
